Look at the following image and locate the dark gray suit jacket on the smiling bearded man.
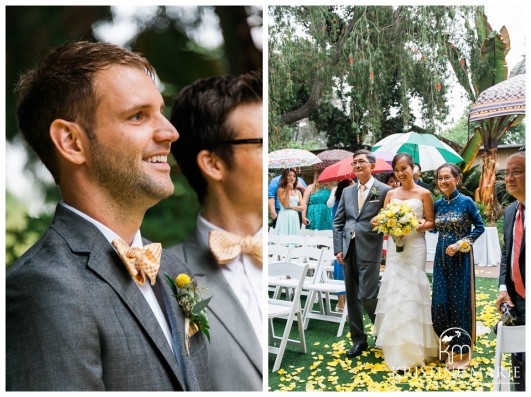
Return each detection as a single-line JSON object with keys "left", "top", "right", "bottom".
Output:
{"left": 6, "top": 205, "right": 210, "bottom": 391}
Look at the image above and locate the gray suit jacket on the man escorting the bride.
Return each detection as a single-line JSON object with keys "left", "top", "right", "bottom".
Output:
{"left": 333, "top": 179, "right": 391, "bottom": 262}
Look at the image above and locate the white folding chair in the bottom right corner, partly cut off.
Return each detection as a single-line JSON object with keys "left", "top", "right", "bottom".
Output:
{"left": 492, "top": 321, "right": 525, "bottom": 391}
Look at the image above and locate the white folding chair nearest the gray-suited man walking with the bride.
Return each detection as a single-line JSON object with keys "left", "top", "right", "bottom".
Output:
{"left": 303, "top": 249, "right": 347, "bottom": 338}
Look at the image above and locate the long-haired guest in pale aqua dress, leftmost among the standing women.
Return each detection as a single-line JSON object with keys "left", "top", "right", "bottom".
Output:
{"left": 273, "top": 168, "right": 305, "bottom": 235}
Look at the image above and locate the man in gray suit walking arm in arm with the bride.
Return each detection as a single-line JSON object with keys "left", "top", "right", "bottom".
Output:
{"left": 333, "top": 150, "right": 390, "bottom": 357}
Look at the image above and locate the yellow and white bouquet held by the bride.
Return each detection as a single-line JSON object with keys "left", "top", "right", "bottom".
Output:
{"left": 373, "top": 202, "right": 419, "bottom": 252}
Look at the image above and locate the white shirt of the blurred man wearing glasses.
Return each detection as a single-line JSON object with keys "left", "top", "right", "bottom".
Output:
{"left": 197, "top": 214, "right": 263, "bottom": 350}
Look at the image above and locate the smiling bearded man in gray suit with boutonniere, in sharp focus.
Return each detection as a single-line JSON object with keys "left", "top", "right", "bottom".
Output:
{"left": 6, "top": 42, "right": 210, "bottom": 391}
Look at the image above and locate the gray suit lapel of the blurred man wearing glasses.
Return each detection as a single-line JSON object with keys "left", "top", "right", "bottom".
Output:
{"left": 183, "top": 239, "right": 262, "bottom": 372}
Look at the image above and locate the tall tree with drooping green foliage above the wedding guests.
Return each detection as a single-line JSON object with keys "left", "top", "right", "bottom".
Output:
{"left": 269, "top": 6, "right": 482, "bottom": 146}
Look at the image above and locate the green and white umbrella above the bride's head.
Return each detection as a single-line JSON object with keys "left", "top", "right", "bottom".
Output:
{"left": 371, "top": 132, "right": 463, "bottom": 171}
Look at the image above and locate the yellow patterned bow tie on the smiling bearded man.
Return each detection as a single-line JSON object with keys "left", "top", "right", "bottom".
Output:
{"left": 112, "top": 238, "right": 162, "bottom": 285}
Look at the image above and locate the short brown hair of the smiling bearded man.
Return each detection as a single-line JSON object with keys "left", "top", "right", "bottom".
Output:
{"left": 15, "top": 41, "right": 155, "bottom": 184}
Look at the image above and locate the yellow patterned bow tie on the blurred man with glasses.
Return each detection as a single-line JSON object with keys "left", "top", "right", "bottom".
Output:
{"left": 208, "top": 230, "right": 262, "bottom": 266}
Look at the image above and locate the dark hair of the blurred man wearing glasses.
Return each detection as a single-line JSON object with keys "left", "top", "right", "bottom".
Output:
{"left": 170, "top": 72, "right": 262, "bottom": 202}
